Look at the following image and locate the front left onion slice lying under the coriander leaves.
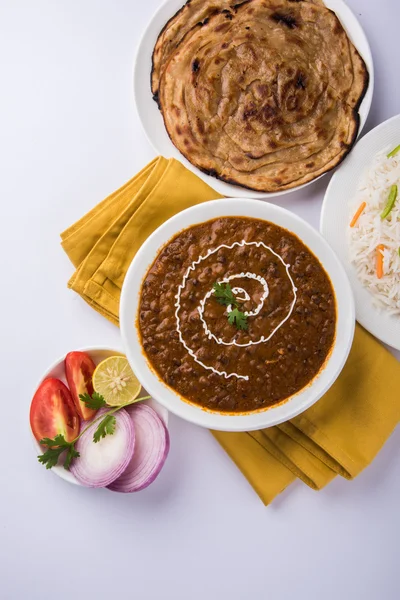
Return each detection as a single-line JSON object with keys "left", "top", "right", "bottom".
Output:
{"left": 71, "top": 408, "right": 135, "bottom": 487}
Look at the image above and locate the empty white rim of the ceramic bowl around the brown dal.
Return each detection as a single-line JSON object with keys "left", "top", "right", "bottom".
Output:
{"left": 120, "top": 198, "right": 355, "bottom": 431}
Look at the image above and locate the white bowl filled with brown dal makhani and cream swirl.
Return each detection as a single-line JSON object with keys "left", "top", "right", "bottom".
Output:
{"left": 120, "top": 199, "right": 355, "bottom": 431}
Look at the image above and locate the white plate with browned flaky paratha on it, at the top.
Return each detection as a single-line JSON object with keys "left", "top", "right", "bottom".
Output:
{"left": 134, "top": 0, "right": 374, "bottom": 198}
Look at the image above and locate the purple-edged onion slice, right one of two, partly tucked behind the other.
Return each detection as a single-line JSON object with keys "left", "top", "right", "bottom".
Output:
{"left": 108, "top": 404, "right": 169, "bottom": 493}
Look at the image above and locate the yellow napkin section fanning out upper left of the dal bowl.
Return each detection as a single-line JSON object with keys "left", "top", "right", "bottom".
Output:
{"left": 61, "top": 157, "right": 221, "bottom": 325}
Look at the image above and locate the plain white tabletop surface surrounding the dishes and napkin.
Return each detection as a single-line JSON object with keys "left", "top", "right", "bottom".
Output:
{"left": 0, "top": 0, "right": 400, "bottom": 600}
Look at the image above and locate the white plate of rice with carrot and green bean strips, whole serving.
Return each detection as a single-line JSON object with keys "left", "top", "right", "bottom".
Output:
{"left": 320, "top": 115, "right": 400, "bottom": 350}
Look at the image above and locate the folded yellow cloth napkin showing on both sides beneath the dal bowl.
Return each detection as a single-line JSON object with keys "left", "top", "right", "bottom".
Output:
{"left": 61, "top": 157, "right": 400, "bottom": 504}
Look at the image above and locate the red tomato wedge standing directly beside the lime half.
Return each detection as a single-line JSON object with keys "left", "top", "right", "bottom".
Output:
{"left": 65, "top": 352, "right": 97, "bottom": 421}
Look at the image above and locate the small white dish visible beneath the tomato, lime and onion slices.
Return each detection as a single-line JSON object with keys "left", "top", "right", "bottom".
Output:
{"left": 31, "top": 346, "right": 168, "bottom": 485}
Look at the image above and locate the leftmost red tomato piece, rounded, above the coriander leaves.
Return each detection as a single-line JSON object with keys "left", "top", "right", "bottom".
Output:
{"left": 30, "top": 377, "right": 80, "bottom": 442}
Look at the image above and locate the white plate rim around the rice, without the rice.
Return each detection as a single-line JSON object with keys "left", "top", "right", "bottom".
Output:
{"left": 320, "top": 115, "right": 400, "bottom": 350}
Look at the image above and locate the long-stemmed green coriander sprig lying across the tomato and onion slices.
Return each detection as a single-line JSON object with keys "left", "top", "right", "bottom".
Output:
{"left": 38, "top": 392, "right": 150, "bottom": 471}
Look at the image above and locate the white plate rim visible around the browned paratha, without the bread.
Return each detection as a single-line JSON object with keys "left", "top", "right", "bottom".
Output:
{"left": 133, "top": 0, "right": 374, "bottom": 198}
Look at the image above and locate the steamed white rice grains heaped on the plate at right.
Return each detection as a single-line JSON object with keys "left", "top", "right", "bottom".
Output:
{"left": 348, "top": 146, "right": 400, "bottom": 315}
